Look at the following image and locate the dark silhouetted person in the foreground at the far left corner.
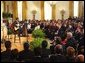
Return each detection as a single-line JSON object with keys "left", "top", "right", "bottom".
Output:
{"left": 1, "top": 41, "right": 12, "bottom": 62}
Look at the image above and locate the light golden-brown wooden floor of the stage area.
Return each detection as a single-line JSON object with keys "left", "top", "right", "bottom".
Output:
{"left": 1, "top": 34, "right": 51, "bottom": 52}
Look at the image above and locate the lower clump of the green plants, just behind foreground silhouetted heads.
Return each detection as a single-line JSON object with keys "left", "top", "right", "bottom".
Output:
{"left": 30, "top": 37, "right": 44, "bottom": 50}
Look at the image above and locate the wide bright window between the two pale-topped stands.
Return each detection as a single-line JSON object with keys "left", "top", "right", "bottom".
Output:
{"left": 44, "top": 1, "right": 52, "bottom": 20}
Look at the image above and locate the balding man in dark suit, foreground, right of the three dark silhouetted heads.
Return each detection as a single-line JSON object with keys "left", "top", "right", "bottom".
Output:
{"left": 50, "top": 44, "right": 66, "bottom": 62}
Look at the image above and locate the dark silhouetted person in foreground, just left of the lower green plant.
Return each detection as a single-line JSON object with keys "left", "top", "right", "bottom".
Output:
{"left": 19, "top": 42, "right": 34, "bottom": 62}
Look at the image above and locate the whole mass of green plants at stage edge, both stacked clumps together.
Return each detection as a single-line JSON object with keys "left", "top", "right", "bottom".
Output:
{"left": 30, "top": 29, "right": 45, "bottom": 50}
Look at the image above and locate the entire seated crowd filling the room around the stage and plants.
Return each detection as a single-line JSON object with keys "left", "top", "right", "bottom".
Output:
{"left": 1, "top": 17, "right": 84, "bottom": 62}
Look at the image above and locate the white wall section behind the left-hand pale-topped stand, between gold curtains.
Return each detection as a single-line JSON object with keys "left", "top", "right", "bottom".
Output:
{"left": 27, "top": 1, "right": 41, "bottom": 20}
